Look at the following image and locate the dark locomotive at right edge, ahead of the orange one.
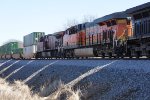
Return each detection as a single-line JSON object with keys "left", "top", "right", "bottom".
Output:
{"left": 126, "top": 2, "right": 150, "bottom": 58}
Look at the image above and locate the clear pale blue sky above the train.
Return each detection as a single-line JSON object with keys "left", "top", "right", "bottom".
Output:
{"left": 0, "top": 0, "right": 149, "bottom": 45}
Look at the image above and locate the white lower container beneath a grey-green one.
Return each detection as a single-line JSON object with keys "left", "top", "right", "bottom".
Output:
{"left": 23, "top": 45, "right": 37, "bottom": 59}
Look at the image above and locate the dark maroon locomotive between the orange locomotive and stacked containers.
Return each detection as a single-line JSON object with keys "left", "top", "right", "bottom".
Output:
{"left": 36, "top": 31, "right": 64, "bottom": 58}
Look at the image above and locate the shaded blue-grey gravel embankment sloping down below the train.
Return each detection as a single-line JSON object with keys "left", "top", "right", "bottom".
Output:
{"left": 0, "top": 60, "right": 150, "bottom": 100}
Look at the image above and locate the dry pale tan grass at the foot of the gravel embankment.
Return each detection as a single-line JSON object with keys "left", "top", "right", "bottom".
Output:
{"left": 0, "top": 78, "right": 80, "bottom": 100}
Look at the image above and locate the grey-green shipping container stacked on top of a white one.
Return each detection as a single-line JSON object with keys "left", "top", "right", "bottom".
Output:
{"left": 23, "top": 32, "right": 45, "bottom": 47}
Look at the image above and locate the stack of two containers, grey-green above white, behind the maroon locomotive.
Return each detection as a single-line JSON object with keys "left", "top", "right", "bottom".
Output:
{"left": 23, "top": 32, "right": 45, "bottom": 59}
